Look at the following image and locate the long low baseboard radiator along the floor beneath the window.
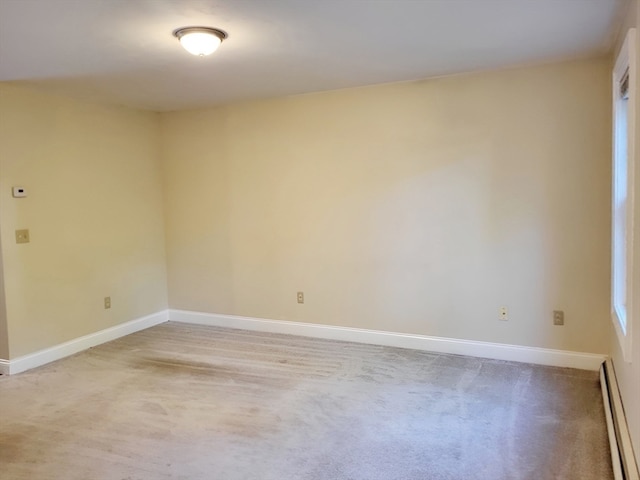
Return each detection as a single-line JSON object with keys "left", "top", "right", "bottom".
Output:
{"left": 600, "top": 359, "right": 640, "bottom": 480}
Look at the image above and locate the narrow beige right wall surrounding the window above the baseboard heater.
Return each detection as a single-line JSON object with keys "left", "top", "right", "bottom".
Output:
{"left": 610, "top": 0, "right": 640, "bottom": 465}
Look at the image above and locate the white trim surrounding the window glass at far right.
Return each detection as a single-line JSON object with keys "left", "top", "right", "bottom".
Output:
{"left": 611, "top": 28, "right": 639, "bottom": 362}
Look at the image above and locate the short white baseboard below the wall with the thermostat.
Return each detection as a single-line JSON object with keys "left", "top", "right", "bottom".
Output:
{"left": 0, "top": 310, "right": 169, "bottom": 375}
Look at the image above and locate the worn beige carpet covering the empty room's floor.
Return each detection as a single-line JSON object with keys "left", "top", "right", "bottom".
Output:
{"left": 0, "top": 323, "right": 612, "bottom": 480}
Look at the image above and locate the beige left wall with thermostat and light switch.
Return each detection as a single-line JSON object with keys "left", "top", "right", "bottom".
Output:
{"left": 0, "top": 84, "right": 167, "bottom": 358}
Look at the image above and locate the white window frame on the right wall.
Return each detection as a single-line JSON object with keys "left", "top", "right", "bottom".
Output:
{"left": 611, "top": 28, "right": 638, "bottom": 362}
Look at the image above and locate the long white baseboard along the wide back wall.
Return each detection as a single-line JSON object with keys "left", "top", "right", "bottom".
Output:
{"left": 169, "top": 310, "right": 606, "bottom": 371}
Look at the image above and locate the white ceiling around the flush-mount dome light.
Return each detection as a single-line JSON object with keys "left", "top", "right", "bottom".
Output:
{"left": 0, "top": 0, "right": 627, "bottom": 111}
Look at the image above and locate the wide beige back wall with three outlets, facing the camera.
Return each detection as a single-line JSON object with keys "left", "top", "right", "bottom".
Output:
{"left": 161, "top": 59, "right": 611, "bottom": 353}
